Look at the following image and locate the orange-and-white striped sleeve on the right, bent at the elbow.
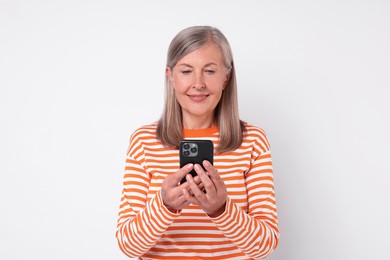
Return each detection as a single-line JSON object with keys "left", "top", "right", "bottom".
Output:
{"left": 212, "top": 130, "right": 279, "bottom": 258}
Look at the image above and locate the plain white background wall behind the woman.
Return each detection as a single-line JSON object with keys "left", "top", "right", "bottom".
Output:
{"left": 0, "top": 0, "right": 390, "bottom": 260}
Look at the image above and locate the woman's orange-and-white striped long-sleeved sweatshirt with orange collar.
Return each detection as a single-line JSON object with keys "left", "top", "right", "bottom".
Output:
{"left": 116, "top": 123, "right": 279, "bottom": 259}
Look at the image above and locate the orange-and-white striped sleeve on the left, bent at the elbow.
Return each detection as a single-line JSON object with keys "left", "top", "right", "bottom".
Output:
{"left": 116, "top": 134, "right": 177, "bottom": 257}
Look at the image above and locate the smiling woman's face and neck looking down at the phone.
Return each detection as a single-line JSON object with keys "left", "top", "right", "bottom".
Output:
{"left": 167, "top": 43, "right": 229, "bottom": 128}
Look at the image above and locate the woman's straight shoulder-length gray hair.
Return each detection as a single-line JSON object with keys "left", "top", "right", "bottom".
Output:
{"left": 157, "top": 26, "right": 245, "bottom": 152}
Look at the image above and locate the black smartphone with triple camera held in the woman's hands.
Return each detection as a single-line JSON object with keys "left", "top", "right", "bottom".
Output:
{"left": 179, "top": 139, "right": 214, "bottom": 184}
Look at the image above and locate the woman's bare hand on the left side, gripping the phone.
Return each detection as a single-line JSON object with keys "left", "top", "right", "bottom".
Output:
{"left": 161, "top": 163, "right": 203, "bottom": 213}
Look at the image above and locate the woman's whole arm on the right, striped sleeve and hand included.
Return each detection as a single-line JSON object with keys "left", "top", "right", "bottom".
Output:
{"left": 183, "top": 131, "right": 279, "bottom": 258}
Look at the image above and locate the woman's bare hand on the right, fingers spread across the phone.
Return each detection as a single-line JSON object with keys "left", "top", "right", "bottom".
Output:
{"left": 183, "top": 161, "right": 227, "bottom": 218}
